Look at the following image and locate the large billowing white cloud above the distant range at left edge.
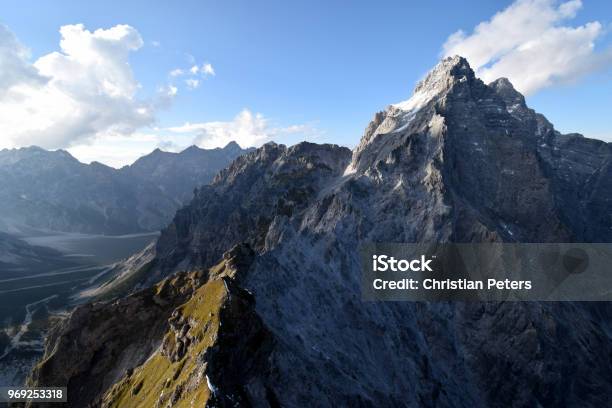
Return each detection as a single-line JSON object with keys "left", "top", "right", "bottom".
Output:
{"left": 0, "top": 24, "right": 170, "bottom": 148}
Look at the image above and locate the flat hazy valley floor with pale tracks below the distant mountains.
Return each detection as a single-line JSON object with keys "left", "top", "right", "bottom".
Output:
{"left": 0, "top": 233, "right": 158, "bottom": 386}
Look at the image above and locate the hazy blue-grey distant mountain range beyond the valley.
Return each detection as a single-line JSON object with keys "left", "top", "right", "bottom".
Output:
{"left": 0, "top": 142, "right": 249, "bottom": 234}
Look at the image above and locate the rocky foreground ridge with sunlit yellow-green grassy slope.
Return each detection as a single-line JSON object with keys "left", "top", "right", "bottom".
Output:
{"left": 29, "top": 245, "right": 272, "bottom": 407}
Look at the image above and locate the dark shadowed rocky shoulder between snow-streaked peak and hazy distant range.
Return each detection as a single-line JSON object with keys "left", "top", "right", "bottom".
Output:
{"left": 156, "top": 142, "right": 351, "bottom": 276}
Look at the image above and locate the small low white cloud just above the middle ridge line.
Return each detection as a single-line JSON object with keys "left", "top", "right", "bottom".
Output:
{"left": 168, "top": 109, "right": 318, "bottom": 148}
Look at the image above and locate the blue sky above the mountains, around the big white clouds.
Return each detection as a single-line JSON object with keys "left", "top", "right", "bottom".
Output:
{"left": 0, "top": 0, "right": 612, "bottom": 165}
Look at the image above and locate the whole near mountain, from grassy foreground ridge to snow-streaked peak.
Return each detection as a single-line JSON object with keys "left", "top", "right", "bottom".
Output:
{"left": 29, "top": 57, "right": 612, "bottom": 407}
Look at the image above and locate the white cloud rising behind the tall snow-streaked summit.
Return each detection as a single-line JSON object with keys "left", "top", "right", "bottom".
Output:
{"left": 443, "top": 0, "right": 612, "bottom": 94}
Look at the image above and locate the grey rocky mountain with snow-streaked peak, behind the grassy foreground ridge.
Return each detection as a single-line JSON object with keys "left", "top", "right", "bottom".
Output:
{"left": 28, "top": 57, "right": 612, "bottom": 407}
